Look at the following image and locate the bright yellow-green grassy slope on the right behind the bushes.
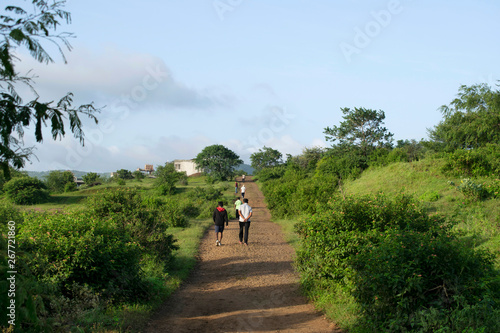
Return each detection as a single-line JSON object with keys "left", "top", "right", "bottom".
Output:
{"left": 344, "top": 159, "right": 500, "bottom": 267}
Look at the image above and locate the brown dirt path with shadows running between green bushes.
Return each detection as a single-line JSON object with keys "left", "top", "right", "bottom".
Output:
{"left": 147, "top": 177, "right": 340, "bottom": 333}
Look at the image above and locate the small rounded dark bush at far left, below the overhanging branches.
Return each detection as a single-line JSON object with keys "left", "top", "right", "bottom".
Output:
{"left": 4, "top": 177, "right": 49, "bottom": 205}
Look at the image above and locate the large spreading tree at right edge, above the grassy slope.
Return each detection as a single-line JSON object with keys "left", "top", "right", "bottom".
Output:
{"left": 428, "top": 84, "right": 500, "bottom": 151}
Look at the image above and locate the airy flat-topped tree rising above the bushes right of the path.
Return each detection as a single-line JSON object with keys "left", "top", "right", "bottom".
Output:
{"left": 324, "top": 108, "right": 394, "bottom": 158}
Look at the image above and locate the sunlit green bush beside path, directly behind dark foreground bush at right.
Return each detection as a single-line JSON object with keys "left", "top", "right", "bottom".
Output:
{"left": 296, "top": 195, "right": 442, "bottom": 286}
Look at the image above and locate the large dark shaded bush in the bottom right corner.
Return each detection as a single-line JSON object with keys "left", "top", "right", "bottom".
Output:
{"left": 350, "top": 229, "right": 500, "bottom": 332}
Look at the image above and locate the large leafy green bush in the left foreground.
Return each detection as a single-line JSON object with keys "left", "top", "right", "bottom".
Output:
{"left": 18, "top": 211, "right": 148, "bottom": 300}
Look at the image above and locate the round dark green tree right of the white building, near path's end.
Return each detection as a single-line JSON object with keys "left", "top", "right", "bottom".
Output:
{"left": 194, "top": 145, "right": 243, "bottom": 180}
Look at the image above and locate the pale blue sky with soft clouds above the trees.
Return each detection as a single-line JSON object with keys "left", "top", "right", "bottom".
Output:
{"left": 8, "top": 0, "right": 500, "bottom": 172}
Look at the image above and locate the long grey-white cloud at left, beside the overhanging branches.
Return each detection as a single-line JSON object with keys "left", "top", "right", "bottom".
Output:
{"left": 17, "top": 47, "right": 234, "bottom": 110}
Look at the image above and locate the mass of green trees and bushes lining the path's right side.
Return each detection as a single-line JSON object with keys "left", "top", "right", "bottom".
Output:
{"left": 251, "top": 85, "right": 500, "bottom": 332}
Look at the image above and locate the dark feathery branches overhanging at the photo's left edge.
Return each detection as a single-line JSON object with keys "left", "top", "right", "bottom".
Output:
{"left": 0, "top": 0, "right": 99, "bottom": 179}
